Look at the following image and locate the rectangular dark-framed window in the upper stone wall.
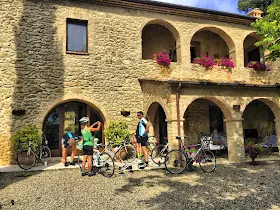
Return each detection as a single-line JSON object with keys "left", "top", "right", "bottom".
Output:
{"left": 66, "top": 19, "right": 88, "bottom": 53}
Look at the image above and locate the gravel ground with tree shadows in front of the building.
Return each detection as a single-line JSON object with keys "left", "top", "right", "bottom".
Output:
{"left": 0, "top": 161, "right": 280, "bottom": 210}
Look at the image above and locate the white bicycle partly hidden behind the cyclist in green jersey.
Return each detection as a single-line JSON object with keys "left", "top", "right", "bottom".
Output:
{"left": 78, "top": 144, "right": 115, "bottom": 177}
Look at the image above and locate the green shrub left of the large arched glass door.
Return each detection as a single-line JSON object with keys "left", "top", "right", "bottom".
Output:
{"left": 12, "top": 125, "right": 42, "bottom": 152}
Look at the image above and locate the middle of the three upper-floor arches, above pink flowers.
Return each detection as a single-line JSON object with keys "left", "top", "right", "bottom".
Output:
{"left": 190, "top": 26, "right": 236, "bottom": 64}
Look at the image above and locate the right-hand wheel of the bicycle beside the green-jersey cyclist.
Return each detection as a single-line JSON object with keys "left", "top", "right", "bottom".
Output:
{"left": 98, "top": 152, "right": 115, "bottom": 177}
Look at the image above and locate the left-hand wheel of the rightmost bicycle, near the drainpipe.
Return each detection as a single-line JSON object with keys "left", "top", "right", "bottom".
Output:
{"left": 165, "top": 150, "right": 187, "bottom": 174}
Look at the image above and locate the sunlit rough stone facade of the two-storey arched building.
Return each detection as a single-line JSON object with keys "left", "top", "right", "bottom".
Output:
{"left": 0, "top": 0, "right": 280, "bottom": 165}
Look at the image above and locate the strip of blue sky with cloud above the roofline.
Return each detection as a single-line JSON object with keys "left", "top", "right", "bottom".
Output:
{"left": 157, "top": 0, "right": 244, "bottom": 14}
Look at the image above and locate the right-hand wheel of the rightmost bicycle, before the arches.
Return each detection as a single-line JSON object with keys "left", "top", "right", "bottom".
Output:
{"left": 198, "top": 150, "right": 216, "bottom": 173}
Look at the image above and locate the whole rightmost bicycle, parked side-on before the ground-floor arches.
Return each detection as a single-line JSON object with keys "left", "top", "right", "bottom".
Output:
{"left": 165, "top": 136, "right": 216, "bottom": 174}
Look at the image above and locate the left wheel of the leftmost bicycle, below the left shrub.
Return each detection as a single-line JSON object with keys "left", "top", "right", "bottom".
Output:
{"left": 17, "top": 150, "right": 36, "bottom": 170}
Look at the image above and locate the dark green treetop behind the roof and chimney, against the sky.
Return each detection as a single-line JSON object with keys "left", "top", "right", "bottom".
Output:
{"left": 238, "top": 0, "right": 273, "bottom": 13}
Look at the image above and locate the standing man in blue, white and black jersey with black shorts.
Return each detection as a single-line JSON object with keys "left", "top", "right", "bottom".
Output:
{"left": 136, "top": 111, "right": 150, "bottom": 169}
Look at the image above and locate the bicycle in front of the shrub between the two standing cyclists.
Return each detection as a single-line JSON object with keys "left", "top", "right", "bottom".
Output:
{"left": 101, "top": 136, "right": 136, "bottom": 163}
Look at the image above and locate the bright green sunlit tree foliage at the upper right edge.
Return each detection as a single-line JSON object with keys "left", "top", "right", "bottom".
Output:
{"left": 252, "top": 0, "right": 280, "bottom": 61}
